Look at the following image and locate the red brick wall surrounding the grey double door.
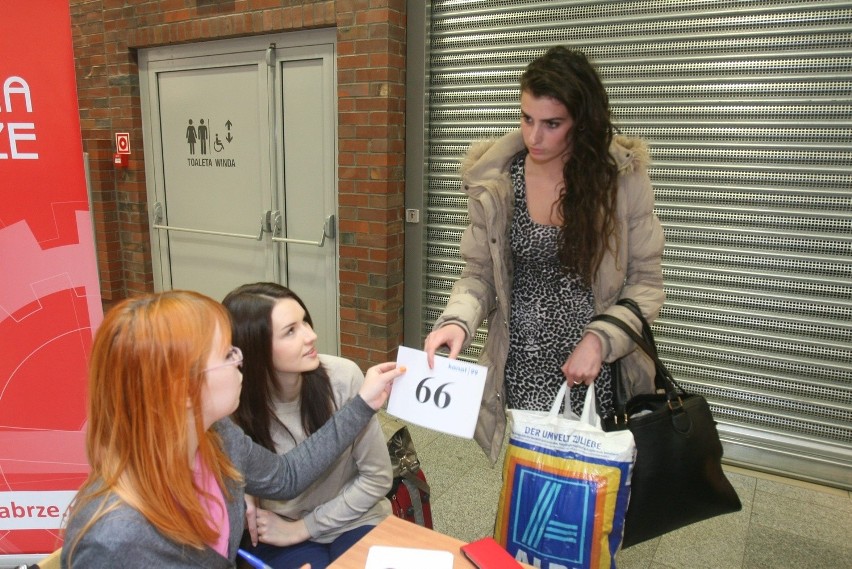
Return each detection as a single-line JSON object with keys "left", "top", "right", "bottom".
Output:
{"left": 69, "top": 0, "right": 406, "bottom": 367}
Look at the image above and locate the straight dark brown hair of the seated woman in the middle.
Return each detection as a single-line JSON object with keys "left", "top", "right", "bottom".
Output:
{"left": 222, "top": 283, "right": 336, "bottom": 452}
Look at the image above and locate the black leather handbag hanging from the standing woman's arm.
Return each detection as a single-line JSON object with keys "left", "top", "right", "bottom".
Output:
{"left": 594, "top": 299, "right": 742, "bottom": 548}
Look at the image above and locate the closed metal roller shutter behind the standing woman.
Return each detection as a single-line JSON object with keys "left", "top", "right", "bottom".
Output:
{"left": 409, "top": 0, "right": 852, "bottom": 488}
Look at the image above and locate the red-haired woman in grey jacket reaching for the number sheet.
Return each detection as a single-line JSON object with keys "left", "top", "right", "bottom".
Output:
{"left": 61, "top": 291, "right": 403, "bottom": 569}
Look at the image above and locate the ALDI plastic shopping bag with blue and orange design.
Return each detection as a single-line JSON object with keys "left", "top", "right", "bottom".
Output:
{"left": 494, "top": 384, "right": 636, "bottom": 569}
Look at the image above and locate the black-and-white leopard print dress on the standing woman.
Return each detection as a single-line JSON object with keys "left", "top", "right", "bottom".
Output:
{"left": 505, "top": 152, "right": 613, "bottom": 417}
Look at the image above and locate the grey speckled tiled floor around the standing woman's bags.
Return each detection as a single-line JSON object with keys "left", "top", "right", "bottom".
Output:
{"left": 380, "top": 412, "right": 852, "bottom": 569}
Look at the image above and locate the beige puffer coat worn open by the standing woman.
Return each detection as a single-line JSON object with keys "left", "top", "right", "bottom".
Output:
{"left": 434, "top": 130, "right": 665, "bottom": 462}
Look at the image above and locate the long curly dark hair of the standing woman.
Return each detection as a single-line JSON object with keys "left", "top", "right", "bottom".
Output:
{"left": 520, "top": 46, "right": 618, "bottom": 285}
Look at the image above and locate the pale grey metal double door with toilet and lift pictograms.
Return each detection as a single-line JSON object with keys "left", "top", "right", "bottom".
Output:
{"left": 140, "top": 33, "right": 339, "bottom": 354}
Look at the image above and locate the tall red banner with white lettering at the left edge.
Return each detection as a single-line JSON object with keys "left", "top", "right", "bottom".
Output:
{"left": 0, "top": 0, "right": 103, "bottom": 555}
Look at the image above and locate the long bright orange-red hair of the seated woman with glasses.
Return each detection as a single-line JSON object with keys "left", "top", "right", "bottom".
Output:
{"left": 64, "top": 290, "right": 241, "bottom": 551}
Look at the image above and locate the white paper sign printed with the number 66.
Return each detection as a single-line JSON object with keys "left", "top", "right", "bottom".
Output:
{"left": 388, "top": 346, "right": 488, "bottom": 439}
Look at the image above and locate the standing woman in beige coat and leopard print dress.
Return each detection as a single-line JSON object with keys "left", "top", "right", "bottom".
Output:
{"left": 424, "top": 46, "right": 664, "bottom": 461}
